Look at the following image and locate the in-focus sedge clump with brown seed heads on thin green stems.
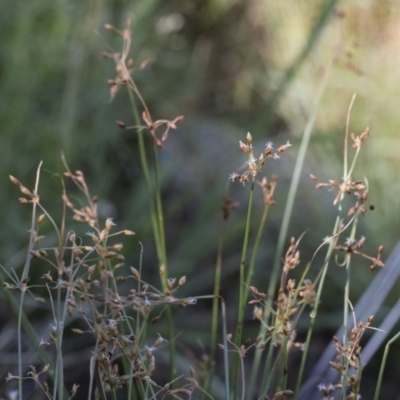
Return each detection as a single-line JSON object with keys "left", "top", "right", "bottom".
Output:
{"left": 0, "top": 15, "right": 394, "bottom": 400}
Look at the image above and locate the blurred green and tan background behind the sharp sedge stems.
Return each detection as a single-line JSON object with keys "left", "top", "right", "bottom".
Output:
{"left": 0, "top": 0, "right": 400, "bottom": 399}
